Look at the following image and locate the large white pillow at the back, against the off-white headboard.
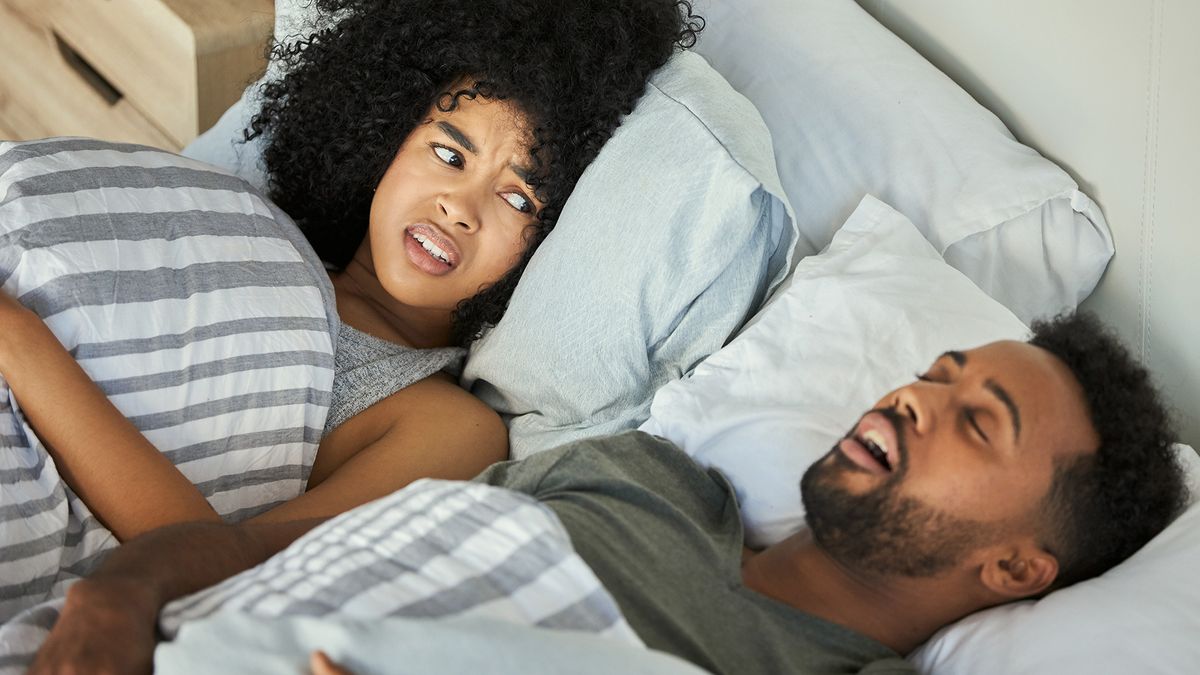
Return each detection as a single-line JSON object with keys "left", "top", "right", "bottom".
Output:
{"left": 697, "top": 0, "right": 1112, "bottom": 322}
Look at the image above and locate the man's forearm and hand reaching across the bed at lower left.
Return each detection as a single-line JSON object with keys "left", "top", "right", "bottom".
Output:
{"left": 30, "top": 519, "right": 323, "bottom": 675}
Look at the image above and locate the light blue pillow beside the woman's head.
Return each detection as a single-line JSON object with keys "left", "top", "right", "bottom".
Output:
{"left": 462, "top": 53, "right": 794, "bottom": 459}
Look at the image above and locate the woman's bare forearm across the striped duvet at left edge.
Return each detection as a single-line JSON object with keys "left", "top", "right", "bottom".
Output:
{"left": 0, "top": 291, "right": 220, "bottom": 542}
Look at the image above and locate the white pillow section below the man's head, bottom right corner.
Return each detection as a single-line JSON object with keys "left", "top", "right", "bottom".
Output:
{"left": 908, "top": 446, "right": 1200, "bottom": 675}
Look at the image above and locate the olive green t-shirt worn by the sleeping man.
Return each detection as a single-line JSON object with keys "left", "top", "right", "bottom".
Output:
{"left": 476, "top": 431, "right": 916, "bottom": 674}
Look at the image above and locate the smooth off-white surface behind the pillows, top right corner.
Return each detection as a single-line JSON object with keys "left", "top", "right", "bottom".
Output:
{"left": 858, "top": 0, "right": 1200, "bottom": 447}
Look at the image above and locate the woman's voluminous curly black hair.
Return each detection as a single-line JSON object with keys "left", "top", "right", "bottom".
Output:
{"left": 246, "top": 0, "right": 703, "bottom": 345}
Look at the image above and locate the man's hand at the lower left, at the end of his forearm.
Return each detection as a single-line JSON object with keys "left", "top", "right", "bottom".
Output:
{"left": 29, "top": 571, "right": 157, "bottom": 675}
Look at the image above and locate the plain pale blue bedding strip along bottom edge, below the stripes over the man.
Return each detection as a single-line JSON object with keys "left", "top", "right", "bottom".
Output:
{"left": 155, "top": 613, "right": 704, "bottom": 675}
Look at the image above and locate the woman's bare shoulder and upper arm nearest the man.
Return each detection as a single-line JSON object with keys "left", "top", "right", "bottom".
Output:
{"left": 252, "top": 375, "right": 509, "bottom": 522}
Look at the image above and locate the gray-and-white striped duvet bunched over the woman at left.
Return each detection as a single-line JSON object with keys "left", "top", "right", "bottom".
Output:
{"left": 0, "top": 138, "right": 337, "bottom": 621}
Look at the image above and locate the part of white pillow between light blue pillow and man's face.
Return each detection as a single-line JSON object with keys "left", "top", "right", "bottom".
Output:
{"left": 642, "top": 197, "right": 1028, "bottom": 546}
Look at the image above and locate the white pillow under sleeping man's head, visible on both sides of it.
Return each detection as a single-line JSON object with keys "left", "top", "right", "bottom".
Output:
{"left": 642, "top": 192, "right": 1200, "bottom": 675}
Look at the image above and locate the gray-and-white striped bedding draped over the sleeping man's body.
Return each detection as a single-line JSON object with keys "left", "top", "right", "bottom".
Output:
{"left": 0, "top": 479, "right": 642, "bottom": 674}
